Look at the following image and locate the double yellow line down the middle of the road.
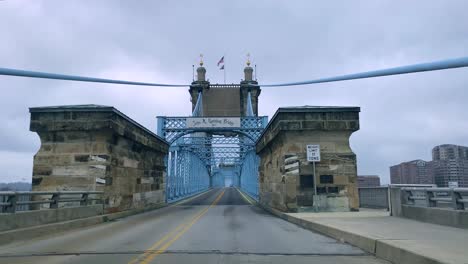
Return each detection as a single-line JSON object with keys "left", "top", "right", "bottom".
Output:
{"left": 128, "top": 190, "right": 225, "bottom": 264}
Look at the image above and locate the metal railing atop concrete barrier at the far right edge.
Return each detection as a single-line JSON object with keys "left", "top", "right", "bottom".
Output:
{"left": 401, "top": 188, "right": 468, "bottom": 210}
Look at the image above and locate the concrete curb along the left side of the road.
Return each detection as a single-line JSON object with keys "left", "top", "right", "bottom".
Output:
{"left": 0, "top": 189, "right": 211, "bottom": 245}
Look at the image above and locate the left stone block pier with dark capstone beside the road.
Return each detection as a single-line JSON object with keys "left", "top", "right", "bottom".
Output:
{"left": 30, "top": 105, "right": 169, "bottom": 211}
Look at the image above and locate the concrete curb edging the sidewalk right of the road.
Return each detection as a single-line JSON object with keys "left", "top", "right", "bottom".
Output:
{"left": 257, "top": 203, "right": 447, "bottom": 264}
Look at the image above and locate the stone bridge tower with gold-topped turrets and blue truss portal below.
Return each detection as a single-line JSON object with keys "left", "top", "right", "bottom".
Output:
{"left": 157, "top": 58, "right": 268, "bottom": 201}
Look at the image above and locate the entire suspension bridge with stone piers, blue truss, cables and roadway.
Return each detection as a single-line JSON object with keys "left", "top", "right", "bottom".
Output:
{"left": 0, "top": 54, "right": 468, "bottom": 263}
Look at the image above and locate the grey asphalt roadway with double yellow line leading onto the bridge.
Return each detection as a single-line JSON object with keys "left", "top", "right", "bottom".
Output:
{"left": 0, "top": 188, "right": 387, "bottom": 264}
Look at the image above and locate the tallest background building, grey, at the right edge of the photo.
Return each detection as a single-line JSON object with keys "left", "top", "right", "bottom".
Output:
{"left": 432, "top": 144, "right": 468, "bottom": 187}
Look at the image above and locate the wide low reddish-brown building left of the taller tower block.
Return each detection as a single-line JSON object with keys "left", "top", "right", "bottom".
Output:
{"left": 390, "top": 160, "right": 434, "bottom": 184}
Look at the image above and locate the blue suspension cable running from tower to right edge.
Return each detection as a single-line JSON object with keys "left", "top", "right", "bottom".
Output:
{"left": 262, "top": 57, "right": 468, "bottom": 87}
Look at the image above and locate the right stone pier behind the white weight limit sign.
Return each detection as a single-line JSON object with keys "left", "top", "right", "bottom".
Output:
{"left": 256, "top": 107, "right": 360, "bottom": 212}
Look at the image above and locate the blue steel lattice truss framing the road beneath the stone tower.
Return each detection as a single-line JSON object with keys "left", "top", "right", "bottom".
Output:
{"left": 157, "top": 116, "right": 268, "bottom": 202}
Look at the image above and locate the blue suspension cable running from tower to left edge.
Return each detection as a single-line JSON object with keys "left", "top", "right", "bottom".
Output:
{"left": 0, "top": 68, "right": 189, "bottom": 87}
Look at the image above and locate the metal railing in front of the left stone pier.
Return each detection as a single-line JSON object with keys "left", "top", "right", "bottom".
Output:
{"left": 0, "top": 191, "right": 103, "bottom": 213}
